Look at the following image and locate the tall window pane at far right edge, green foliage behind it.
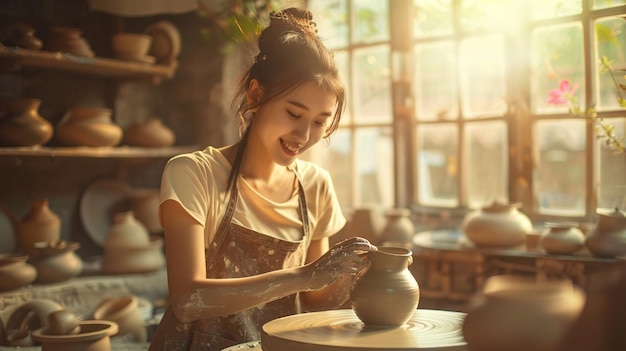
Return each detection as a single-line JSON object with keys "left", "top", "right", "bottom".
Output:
{"left": 595, "top": 17, "right": 626, "bottom": 110}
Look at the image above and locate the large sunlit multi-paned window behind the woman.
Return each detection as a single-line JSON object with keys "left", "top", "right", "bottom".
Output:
{"left": 309, "top": 0, "right": 626, "bottom": 223}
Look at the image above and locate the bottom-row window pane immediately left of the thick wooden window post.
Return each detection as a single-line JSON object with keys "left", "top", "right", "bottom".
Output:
{"left": 354, "top": 127, "right": 394, "bottom": 207}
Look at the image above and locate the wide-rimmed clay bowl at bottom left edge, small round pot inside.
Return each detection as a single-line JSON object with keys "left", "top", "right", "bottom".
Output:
{"left": 32, "top": 321, "right": 118, "bottom": 351}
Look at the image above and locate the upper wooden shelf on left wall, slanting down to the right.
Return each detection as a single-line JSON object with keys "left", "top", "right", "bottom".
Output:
{"left": 0, "top": 44, "right": 178, "bottom": 83}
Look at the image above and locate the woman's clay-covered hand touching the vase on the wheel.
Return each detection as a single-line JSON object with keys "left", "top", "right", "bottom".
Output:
{"left": 306, "top": 237, "right": 377, "bottom": 291}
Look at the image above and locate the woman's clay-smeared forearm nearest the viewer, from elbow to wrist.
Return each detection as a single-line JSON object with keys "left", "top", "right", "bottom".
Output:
{"left": 171, "top": 267, "right": 307, "bottom": 322}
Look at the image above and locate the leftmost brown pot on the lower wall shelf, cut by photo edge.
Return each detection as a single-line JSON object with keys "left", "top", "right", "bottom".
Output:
{"left": 0, "top": 98, "right": 54, "bottom": 146}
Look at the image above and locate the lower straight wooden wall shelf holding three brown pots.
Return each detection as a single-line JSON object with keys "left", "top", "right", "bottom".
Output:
{"left": 0, "top": 145, "right": 199, "bottom": 158}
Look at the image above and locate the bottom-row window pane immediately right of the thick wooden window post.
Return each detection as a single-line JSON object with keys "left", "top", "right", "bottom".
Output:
{"left": 417, "top": 124, "right": 459, "bottom": 207}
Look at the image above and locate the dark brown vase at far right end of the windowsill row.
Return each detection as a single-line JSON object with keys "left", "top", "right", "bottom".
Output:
{"left": 585, "top": 208, "right": 626, "bottom": 258}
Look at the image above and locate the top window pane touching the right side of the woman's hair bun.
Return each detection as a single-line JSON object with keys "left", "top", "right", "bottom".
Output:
{"left": 309, "top": 0, "right": 349, "bottom": 49}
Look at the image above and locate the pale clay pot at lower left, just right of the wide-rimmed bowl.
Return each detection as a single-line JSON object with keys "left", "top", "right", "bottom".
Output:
{"left": 93, "top": 296, "right": 148, "bottom": 342}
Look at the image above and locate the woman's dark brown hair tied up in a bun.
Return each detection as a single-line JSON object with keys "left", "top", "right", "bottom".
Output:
{"left": 233, "top": 8, "right": 345, "bottom": 137}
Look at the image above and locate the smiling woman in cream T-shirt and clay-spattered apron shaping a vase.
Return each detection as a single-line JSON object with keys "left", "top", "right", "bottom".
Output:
{"left": 150, "top": 8, "right": 376, "bottom": 351}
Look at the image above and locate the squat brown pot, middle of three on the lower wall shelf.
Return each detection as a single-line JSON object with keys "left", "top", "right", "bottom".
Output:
{"left": 56, "top": 107, "right": 123, "bottom": 147}
